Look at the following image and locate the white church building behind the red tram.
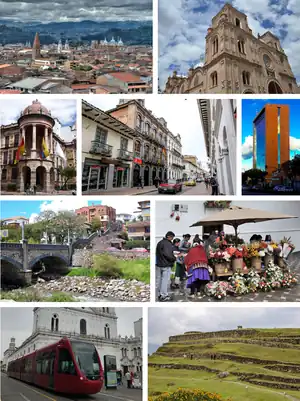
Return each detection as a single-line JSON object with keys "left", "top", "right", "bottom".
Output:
{"left": 4, "top": 308, "right": 143, "bottom": 374}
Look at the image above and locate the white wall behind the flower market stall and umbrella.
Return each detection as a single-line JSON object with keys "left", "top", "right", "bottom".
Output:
{"left": 155, "top": 198, "right": 300, "bottom": 251}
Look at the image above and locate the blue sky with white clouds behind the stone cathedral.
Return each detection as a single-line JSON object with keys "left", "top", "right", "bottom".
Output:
{"left": 158, "top": 0, "right": 300, "bottom": 89}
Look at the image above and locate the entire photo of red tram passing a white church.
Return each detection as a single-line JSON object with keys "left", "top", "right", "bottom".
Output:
{"left": 1, "top": 307, "right": 143, "bottom": 401}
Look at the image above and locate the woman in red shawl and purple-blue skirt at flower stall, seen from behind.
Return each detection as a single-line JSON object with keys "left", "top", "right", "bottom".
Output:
{"left": 184, "top": 241, "right": 210, "bottom": 298}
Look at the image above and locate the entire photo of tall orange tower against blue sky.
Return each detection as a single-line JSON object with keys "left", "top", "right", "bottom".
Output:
{"left": 242, "top": 99, "right": 300, "bottom": 195}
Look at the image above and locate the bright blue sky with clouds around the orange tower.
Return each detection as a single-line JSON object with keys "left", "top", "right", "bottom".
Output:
{"left": 242, "top": 99, "right": 300, "bottom": 170}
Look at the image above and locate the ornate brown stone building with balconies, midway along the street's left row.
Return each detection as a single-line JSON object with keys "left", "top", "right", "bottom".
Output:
{"left": 108, "top": 99, "right": 169, "bottom": 186}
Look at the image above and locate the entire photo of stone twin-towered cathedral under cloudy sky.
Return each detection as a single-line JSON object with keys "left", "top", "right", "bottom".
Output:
{"left": 158, "top": 0, "right": 300, "bottom": 94}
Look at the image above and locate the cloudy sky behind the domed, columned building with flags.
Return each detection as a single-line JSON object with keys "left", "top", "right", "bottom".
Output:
{"left": 0, "top": 98, "right": 76, "bottom": 141}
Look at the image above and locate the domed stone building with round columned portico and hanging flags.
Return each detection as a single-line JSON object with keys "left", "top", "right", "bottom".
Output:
{"left": 0, "top": 100, "right": 76, "bottom": 193}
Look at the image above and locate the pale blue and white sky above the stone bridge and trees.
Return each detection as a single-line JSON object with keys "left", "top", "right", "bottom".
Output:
{"left": 1, "top": 196, "right": 144, "bottom": 223}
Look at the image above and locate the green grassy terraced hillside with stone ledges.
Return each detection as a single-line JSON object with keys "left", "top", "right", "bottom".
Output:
{"left": 148, "top": 328, "right": 300, "bottom": 401}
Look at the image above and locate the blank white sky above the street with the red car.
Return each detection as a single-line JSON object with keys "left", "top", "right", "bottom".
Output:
{"left": 85, "top": 95, "right": 207, "bottom": 162}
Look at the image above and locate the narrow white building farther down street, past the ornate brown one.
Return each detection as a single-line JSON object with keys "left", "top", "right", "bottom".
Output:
{"left": 167, "top": 132, "right": 184, "bottom": 180}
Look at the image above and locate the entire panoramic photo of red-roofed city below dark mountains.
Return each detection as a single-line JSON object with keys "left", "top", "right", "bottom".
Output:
{"left": 0, "top": 0, "right": 152, "bottom": 94}
